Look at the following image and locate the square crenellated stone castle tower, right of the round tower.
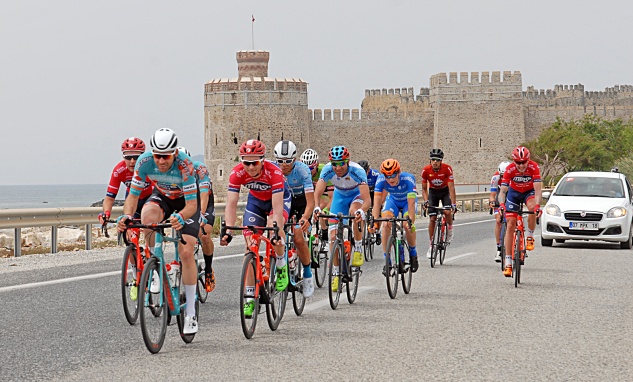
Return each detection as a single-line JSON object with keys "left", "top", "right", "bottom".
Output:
{"left": 429, "top": 71, "right": 525, "bottom": 184}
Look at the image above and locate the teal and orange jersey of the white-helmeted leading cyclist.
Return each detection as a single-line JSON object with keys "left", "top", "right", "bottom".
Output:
{"left": 130, "top": 151, "right": 198, "bottom": 201}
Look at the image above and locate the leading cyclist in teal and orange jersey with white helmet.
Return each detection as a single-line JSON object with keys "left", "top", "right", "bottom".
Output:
{"left": 117, "top": 128, "right": 200, "bottom": 334}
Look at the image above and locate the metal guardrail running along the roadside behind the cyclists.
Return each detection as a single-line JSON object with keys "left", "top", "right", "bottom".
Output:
{"left": 0, "top": 192, "right": 504, "bottom": 257}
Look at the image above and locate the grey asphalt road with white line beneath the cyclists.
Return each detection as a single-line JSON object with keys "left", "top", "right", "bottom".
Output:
{"left": 0, "top": 213, "right": 633, "bottom": 381}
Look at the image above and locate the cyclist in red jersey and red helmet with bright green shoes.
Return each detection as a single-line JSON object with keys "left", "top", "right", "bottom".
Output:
{"left": 220, "top": 139, "right": 291, "bottom": 318}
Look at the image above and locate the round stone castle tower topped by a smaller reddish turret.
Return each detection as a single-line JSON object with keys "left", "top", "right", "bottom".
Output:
{"left": 204, "top": 50, "right": 309, "bottom": 197}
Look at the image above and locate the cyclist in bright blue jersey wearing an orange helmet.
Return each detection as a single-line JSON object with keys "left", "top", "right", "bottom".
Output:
{"left": 372, "top": 159, "right": 418, "bottom": 272}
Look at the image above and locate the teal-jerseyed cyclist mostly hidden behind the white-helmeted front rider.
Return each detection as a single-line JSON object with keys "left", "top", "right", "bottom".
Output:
{"left": 178, "top": 147, "right": 215, "bottom": 293}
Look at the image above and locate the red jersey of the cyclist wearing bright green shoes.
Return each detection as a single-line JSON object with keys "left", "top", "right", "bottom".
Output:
{"left": 229, "top": 160, "right": 284, "bottom": 200}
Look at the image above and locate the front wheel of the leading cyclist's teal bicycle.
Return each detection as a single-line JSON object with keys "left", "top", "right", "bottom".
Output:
{"left": 139, "top": 257, "right": 169, "bottom": 354}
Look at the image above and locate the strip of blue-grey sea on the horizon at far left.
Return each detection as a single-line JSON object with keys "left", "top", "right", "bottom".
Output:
{"left": 0, "top": 184, "right": 119, "bottom": 209}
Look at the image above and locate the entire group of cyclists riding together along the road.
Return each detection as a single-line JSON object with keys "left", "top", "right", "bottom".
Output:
{"left": 99, "top": 128, "right": 541, "bottom": 334}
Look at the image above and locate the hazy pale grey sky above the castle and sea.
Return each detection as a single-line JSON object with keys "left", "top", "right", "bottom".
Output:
{"left": 0, "top": 0, "right": 633, "bottom": 185}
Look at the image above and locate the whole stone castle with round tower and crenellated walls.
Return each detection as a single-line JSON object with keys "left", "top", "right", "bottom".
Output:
{"left": 204, "top": 50, "right": 633, "bottom": 195}
